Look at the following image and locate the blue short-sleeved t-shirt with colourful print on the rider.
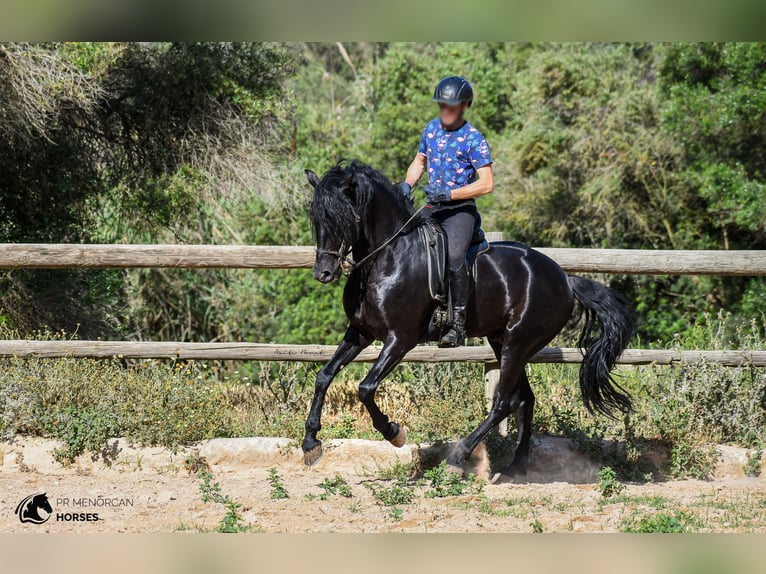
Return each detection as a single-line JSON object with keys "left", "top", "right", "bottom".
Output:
{"left": 418, "top": 118, "right": 492, "bottom": 210}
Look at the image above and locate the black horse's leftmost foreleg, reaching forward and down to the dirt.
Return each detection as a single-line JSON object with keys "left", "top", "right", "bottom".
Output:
{"left": 301, "top": 327, "right": 372, "bottom": 466}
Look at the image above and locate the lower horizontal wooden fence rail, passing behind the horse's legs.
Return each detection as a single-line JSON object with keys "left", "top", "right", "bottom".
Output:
{"left": 0, "top": 340, "right": 766, "bottom": 367}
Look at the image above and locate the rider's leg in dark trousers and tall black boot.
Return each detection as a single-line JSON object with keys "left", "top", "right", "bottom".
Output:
{"left": 439, "top": 211, "right": 475, "bottom": 347}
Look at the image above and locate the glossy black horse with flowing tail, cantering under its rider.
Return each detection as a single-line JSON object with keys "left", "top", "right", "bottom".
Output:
{"left": 302, "top": 161, "right": 633, "bottom": 482}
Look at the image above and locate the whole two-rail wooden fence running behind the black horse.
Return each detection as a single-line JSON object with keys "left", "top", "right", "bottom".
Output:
{"left": 0, "top": 242, "right": 766, "bottom": 366}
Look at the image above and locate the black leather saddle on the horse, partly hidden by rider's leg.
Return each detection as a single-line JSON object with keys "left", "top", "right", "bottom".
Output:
{"left": 419, "top": 220, "right": 490, "bottom": 327}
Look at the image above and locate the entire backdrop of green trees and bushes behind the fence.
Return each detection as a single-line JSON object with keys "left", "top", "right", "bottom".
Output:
{"left": 0, "top": 42, "right": 766, "bottom": 343}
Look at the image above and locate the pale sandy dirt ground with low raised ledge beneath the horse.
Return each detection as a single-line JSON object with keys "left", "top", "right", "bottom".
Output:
{"left": 0, "top": 438, "right": 766, "bottom": 532}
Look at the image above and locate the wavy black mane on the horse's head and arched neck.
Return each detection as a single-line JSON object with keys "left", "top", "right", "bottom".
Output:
{"left": 310, "top": 160, "right": 414, "bottom": 246}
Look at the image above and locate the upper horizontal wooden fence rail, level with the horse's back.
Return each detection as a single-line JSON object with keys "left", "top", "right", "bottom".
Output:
{"left": 0, "top": 243, "right": 766, "bottom": 276}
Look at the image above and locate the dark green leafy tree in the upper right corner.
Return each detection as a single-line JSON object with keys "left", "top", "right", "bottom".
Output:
{"left": 659, "top": 43, "right": 766, "bottom": 236}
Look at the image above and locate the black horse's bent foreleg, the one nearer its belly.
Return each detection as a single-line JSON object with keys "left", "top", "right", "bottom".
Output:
{"left": 359, "top": 339, "right": 415, "bottom": 447}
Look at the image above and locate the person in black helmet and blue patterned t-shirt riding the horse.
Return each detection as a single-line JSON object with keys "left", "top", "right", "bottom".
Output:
{"left": 401, "top": 76, "right": 494, "bottom": 347}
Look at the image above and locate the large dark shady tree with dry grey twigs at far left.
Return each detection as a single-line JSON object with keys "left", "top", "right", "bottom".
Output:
{"left": 0, "top": 43, "right": 294, "bottom": 338}
